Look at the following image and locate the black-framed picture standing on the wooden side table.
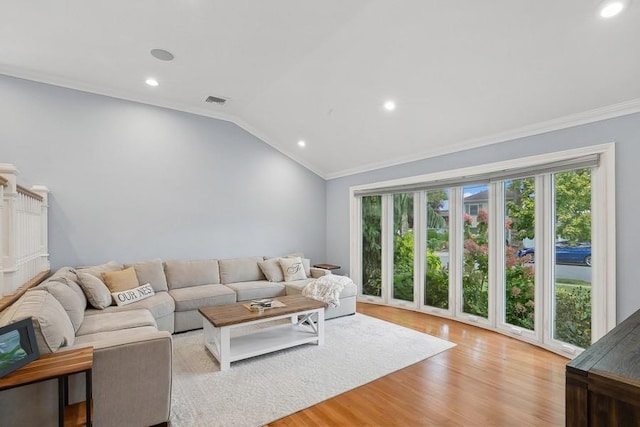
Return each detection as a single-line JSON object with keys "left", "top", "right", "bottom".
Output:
{"left": 0, "top": 317, "right": 40, "bottom": 377}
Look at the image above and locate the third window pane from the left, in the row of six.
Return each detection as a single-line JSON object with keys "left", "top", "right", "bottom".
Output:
{"left": 424, "top": 189, "right": 449, "bottom": 309}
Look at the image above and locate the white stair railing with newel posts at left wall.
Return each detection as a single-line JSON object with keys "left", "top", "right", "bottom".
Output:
{"left": 0, "top": 163, "right": 50, "bottom": 297}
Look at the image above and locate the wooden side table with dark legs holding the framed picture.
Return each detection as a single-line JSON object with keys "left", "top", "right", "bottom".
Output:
{"left": 0, "top": 347, "right": 93, "bottom": 427}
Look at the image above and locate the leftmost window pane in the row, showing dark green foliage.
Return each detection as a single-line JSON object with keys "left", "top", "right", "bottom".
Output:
{"left": 362, "top": 196, "right": 382, "bottom": 297}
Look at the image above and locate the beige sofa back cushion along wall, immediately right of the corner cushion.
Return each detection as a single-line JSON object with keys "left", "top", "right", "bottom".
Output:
{"left": 164, "top": 259, "right": 220, "bottom": 289}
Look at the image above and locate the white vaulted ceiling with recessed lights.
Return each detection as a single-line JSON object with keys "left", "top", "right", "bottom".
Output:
{"left": 0, "top": 0, "right": 640, "bottom": 178}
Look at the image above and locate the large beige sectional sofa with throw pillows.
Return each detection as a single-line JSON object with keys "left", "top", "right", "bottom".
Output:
{"left": 0, "top": 256, "right": 356, "bottom": 426}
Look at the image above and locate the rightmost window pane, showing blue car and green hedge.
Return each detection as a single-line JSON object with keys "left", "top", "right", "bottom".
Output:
{"left": 554, "top": 169, "right": 591, "bottom": 348}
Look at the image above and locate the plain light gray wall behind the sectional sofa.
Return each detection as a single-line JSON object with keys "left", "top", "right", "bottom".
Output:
{"left": 0, "top": 75, "right": 326, "bottom": 268}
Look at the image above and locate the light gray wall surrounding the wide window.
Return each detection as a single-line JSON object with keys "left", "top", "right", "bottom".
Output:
{"left": 327, "top": 114, "right": 640, "bottom": 321}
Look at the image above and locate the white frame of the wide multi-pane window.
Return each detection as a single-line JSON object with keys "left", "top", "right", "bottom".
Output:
{"left": 349, "top": 142, "right": 616, "bottom": 357}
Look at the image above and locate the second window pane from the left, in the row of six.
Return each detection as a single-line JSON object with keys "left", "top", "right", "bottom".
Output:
{"left": 393, "top": 193, "right": 414, "bottom": 301}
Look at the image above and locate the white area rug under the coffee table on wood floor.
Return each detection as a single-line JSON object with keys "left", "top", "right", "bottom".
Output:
{"left": 171, "top": 313, "right": 455, "bottom": 427}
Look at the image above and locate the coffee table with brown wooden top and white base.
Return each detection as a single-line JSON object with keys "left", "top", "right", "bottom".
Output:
{"left": 199, "top": 295, "right": 325, "bottom": 371}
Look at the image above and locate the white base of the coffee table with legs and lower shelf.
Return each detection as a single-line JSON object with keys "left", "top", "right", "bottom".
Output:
{"left": 203, "top": 308, "right": 324, "bottom": 371}
